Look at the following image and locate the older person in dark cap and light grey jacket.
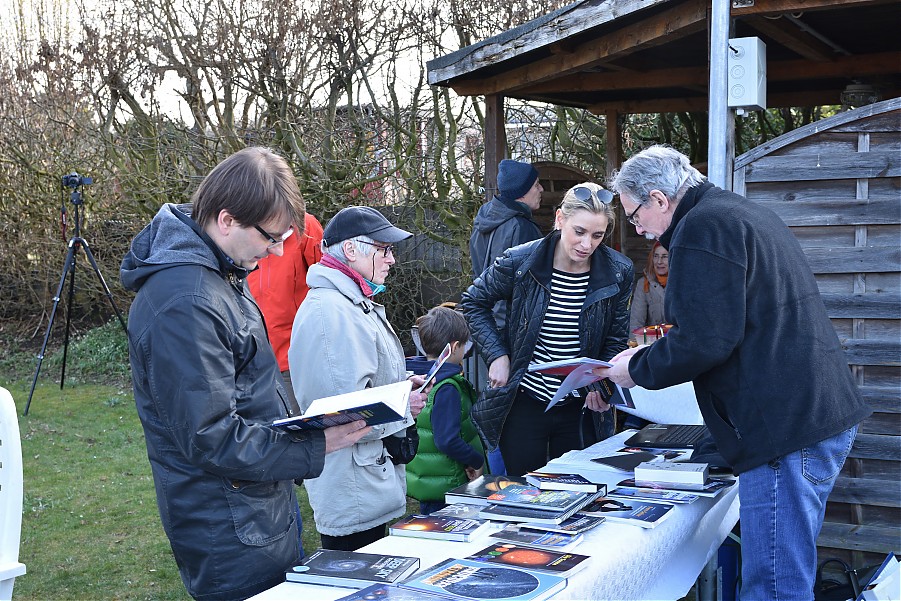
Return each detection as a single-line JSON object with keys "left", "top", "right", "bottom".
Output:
{"left": 288, "top": 207, "right": 428, "bottom": 551}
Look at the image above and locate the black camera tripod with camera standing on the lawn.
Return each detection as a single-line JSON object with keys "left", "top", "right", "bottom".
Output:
{"left": 22, "top": 172, "right": 128, "bottom": 415}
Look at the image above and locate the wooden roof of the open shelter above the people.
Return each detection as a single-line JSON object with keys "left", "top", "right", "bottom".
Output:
{"left": 427, "top": 0, "right": 901, "bottom": 113}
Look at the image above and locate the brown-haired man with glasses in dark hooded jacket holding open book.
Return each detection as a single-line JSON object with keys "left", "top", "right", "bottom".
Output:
{"left": 120, "top": 148, "right": 369, "bottom": 600}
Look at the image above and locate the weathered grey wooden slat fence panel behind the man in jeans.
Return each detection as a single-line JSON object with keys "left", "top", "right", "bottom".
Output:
{"left": 733, "top": 98, "right": 901, "bottom": 567}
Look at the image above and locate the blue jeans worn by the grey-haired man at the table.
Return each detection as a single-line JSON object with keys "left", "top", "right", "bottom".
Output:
{"left": 738, "top": 426, "right": 857, "bottom": 601}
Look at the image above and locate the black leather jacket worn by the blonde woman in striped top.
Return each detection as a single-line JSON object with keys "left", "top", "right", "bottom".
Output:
{"left": 462, "top": 231, "right": 634, "bottom": 449}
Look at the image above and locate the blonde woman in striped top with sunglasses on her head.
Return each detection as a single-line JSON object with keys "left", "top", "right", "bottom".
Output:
{"left": 462, "top": 182, "right": 634, "bottom": 476}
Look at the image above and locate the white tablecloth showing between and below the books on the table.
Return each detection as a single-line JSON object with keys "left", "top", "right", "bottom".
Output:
{"left": 253, "top": 431, "right": 738, "bottom": 601}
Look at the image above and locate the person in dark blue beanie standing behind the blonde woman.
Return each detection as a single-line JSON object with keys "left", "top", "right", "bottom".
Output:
{"left": 466, "top": 159, "right": 544, "bottom": 475}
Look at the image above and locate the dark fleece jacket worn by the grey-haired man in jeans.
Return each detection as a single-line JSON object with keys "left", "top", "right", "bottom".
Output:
{"left": 629, "top": 182, "right": 870, "bottom": 473}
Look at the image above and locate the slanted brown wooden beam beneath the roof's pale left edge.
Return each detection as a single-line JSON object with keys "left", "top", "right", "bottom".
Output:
{"left": 450, "top": 0, "right": 707, "bottom": 96}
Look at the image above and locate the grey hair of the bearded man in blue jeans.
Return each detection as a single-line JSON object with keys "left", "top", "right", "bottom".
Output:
{"left": 610, "top": 145, "right": 707, "bottom": 205}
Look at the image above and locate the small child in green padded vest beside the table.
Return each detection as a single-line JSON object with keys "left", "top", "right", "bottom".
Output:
{"left": 407, "top": 306, "right": 485, "bottom": 513}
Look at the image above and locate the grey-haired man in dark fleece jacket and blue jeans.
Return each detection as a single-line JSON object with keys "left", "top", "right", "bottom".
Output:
{"left": 598, "top": 146, "right": 870, "bottom": 601}
